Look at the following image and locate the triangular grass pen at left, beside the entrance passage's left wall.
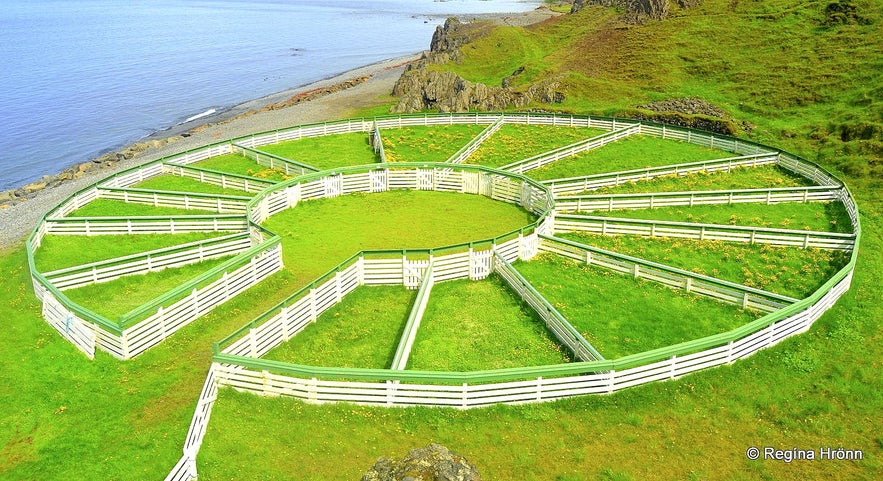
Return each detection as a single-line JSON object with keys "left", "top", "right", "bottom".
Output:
{"left": 64, "top": 256, "right": 230, "bottom": 319}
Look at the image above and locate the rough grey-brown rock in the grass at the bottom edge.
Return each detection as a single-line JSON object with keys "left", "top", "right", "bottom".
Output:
{"left": 362, "top": 444, "right": 481, "bottom": 481}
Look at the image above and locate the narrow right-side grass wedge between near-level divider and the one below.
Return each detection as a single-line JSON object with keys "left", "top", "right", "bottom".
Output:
{"left": 589, "top": 202, "right": 852, "bottom": 233}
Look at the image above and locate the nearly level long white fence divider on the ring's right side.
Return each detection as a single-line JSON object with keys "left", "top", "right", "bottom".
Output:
{"left": 555, "top": 186, "right": 842, "bottom": 212}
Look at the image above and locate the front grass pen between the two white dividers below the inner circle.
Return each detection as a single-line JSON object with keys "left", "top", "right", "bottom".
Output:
{"left": 408, "top": 276, "right": 569, "bottom": 372}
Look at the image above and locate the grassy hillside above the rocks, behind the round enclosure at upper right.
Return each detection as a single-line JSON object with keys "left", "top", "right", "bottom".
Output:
{"left": 420, "top": 0, "right": 883, "bottom": 179}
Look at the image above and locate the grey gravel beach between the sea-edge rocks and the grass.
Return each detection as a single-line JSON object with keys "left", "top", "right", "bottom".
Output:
{"left": 0, "top": 7, "right": 557, "bottom": 251}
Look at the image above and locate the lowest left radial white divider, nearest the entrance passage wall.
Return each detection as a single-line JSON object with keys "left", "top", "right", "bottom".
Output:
{"left": 43, "top": 232, "right": 252, "bottom": 290}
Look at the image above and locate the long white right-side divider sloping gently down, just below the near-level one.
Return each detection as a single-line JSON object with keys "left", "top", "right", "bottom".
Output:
{"left": 554, "top": 214, "right": 855, "bottom": 251}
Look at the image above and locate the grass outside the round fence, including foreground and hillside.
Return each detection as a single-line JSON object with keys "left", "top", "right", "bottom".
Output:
{"left": 0, "top": 0, "right": 883, "bottom": 481}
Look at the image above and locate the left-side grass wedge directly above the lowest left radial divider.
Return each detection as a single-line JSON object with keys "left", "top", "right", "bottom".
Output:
{"left": 34, "top": 232, "right": 231, "bottom": 272}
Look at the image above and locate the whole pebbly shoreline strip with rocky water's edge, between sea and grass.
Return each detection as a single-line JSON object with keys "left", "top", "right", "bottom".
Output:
{"left": 0, "top": 6, "right": 558, "bottom": 251}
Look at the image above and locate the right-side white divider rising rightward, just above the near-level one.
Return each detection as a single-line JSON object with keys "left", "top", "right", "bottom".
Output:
{"left": 540, "top": 152, "right": 779, "bottom": 196}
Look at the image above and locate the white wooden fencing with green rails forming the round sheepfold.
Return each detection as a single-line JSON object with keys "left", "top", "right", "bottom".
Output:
{"left": 27, "top": 113, "right": 861, "bottom": 480}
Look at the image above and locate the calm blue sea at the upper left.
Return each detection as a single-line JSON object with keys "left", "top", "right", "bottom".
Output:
{"left": 0, "top": 0, "right": 542, "bottom": 191}
